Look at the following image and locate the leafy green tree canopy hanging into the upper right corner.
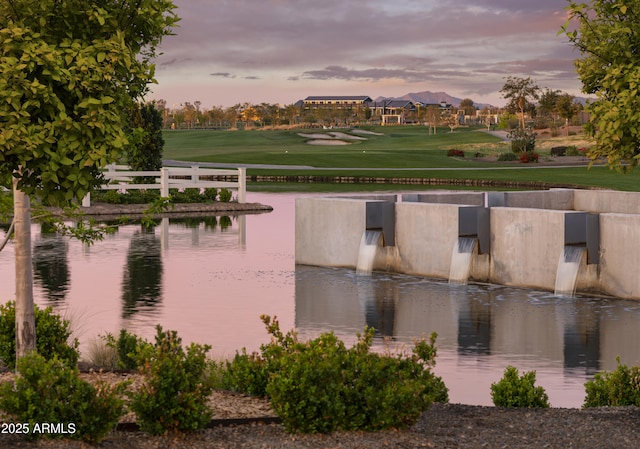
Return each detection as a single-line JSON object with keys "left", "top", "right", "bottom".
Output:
{"left": 562, "top": 0, "right": 640, "bottom": 171}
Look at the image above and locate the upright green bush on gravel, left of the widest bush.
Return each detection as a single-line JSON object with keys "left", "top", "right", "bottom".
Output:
{"left": 129, "top": 326, "right": 215, "bottom": 435}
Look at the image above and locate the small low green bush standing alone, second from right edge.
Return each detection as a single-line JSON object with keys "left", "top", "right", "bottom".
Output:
{"left": 491, "top": 366, "right": 549, "bottom": 408}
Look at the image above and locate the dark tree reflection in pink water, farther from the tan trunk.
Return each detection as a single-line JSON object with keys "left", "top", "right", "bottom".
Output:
{"left": 122, "top": 229, "right": 162, "bottom": 318}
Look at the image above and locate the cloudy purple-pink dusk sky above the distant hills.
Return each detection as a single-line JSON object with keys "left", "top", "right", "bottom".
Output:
{"left": 149, "top": 0, "right": 580, "bottom": 108}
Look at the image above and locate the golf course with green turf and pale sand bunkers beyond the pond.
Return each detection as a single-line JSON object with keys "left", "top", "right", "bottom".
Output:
{"left": 163, "top": 126, "right": 640, "bottom": 191}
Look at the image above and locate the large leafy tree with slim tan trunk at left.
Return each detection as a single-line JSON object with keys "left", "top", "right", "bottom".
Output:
{"left": 0, "top": 0, "right": 178, "bottom": 358}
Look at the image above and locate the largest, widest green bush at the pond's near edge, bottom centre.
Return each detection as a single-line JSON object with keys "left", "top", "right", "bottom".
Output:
{"left": 252, "top": 317, "right": 448, "bottom": 433}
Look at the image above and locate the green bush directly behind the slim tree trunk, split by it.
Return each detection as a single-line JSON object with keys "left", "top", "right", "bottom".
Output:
{"left": 0, "top": 301, "right": 80, "bottom": 370}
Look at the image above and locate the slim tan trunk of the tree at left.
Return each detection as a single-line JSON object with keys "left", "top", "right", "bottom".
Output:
{"left": 13, "top": 173, "right": 36, "bottom": 360}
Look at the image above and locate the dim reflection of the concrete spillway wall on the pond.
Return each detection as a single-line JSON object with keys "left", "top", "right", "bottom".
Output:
{"left": 295, "top": 266, "right": 640, "bottom": 407}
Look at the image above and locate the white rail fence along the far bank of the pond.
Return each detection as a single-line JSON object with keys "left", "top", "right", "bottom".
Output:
{"left": 82, "top": 164, "right": 247, "bottom": 207}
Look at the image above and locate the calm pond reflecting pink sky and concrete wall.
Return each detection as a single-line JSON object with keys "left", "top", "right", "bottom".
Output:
{"left": 0, "top": 192, "right": 640, "bottom": 407}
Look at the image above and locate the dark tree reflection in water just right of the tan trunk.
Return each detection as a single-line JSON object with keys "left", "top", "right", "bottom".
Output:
{"left": 33, "top": 226, "right": 70, "bottom": 301}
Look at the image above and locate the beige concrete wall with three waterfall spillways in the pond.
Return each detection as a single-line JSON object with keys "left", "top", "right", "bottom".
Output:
{"left": 295, "top": 189, "right": 640, "bottom": 299}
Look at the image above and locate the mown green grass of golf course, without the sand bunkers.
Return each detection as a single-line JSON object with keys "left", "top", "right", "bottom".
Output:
{"left": 163, "top": 126, "right": 640, "bottom": 191}
